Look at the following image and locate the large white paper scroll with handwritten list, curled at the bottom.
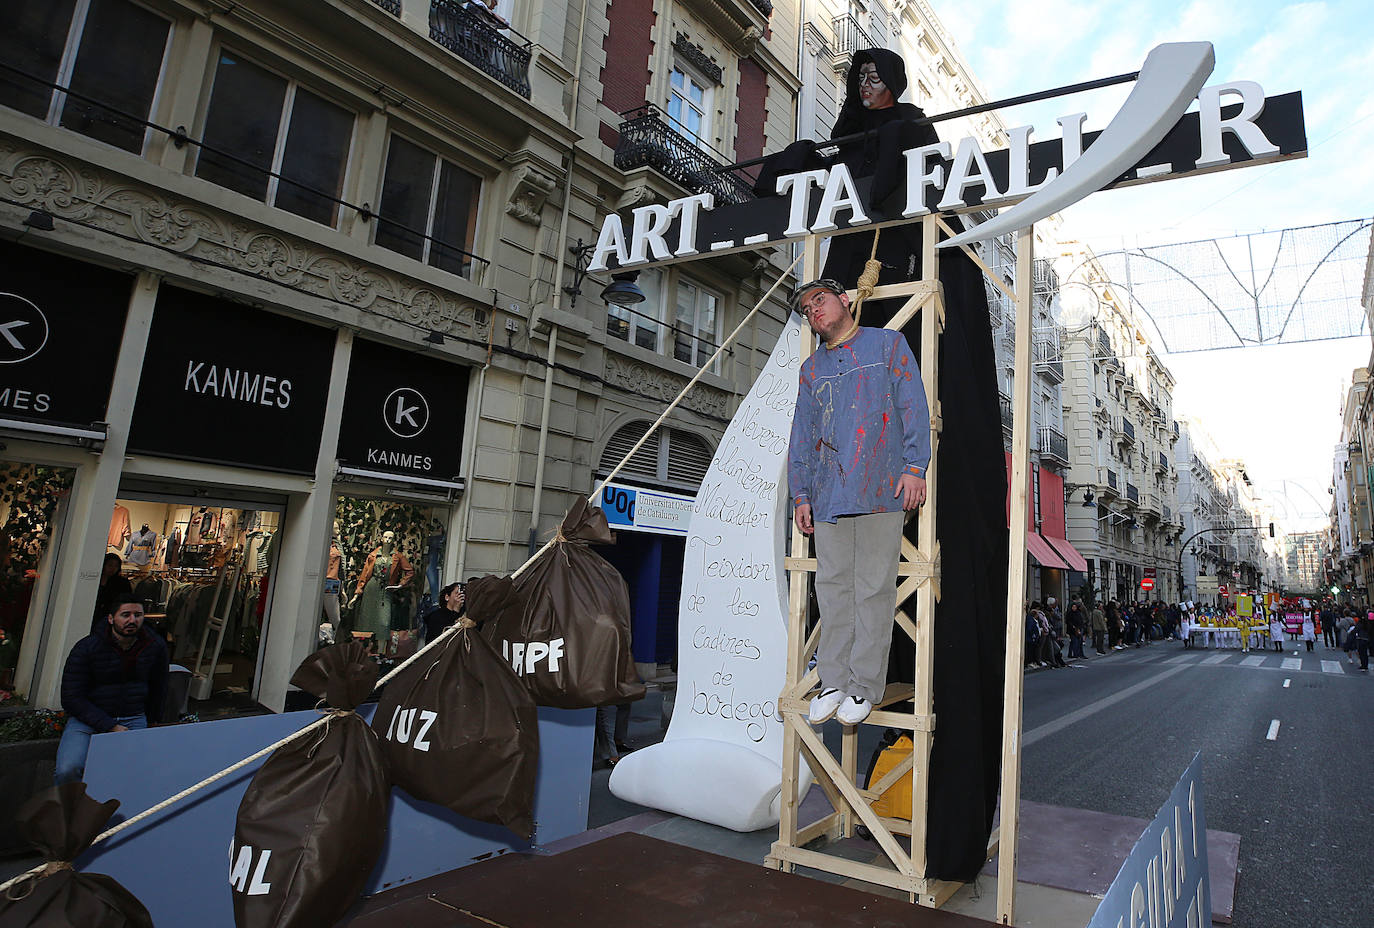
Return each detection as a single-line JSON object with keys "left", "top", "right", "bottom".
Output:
{"left": 610, "top": 315, "right": 811, "bottom": 832}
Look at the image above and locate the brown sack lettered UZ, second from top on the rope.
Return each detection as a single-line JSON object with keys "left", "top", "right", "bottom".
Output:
{"left": 372, "top": 615, "right": 539, "bottom": 840}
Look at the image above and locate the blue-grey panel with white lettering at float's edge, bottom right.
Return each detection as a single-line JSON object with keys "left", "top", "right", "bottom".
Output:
{"left": 1088, "top": 752, "right": 1212, "bottom": 928}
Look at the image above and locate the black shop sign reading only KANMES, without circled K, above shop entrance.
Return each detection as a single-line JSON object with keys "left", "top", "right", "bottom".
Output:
{"left": 129, "top": 285, "right": 335, "bottom": 474}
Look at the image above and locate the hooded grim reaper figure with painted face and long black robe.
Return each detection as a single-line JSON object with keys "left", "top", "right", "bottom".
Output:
{"left": 754, "top": 48, "right": 1007, "bottom": 881}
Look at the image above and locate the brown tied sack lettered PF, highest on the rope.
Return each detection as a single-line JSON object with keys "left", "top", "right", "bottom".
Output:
{"left": 469, "top": 499, "right": 644, "bottom": 709}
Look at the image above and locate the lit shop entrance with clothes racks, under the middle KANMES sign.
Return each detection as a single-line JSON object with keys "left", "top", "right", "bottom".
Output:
{"left": 105, "top": 499, "right": 280, "bottom": 718}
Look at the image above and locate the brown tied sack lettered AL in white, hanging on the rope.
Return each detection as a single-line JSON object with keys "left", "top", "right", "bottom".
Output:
{"left": 229, "top": 641, "right": 390, "bottom": 928}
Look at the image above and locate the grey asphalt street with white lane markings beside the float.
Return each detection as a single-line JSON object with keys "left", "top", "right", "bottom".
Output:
{"left": 1021, "top": 642, "right": 1374, "bottom": 928}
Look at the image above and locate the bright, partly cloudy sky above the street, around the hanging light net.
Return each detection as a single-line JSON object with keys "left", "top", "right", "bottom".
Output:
{"left": 930, "top": 0, "right": 1374, "bottom": 528}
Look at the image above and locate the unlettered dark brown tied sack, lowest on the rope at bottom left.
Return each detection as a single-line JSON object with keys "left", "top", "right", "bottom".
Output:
{"left": 0, "top": 782, "right": 153, "bottom": 928}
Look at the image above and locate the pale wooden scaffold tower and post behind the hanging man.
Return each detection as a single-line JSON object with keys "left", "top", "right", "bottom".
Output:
{"left": 765, "top": 216, "right": 1031, "bottom": 924}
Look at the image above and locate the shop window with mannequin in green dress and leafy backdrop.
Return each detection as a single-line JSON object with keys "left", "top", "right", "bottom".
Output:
{"left": 329, "top": 496, "right": 448, "bottom": 659}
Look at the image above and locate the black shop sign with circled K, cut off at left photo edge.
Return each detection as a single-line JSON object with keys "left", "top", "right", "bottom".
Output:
{"left": 0, "top": 242, "right": 133, "bottom": 429}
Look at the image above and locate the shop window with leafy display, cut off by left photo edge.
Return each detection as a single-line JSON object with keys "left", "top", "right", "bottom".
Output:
{"left": 0, "top": 462, "right": 73, "bottom": 690}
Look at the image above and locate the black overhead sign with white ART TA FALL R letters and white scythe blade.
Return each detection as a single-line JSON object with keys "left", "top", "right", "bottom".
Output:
{"left": 589, "top": 43, "right": 1307, "bottom": 271}
